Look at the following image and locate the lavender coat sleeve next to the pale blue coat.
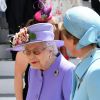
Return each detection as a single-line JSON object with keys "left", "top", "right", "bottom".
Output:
{"left": 63, "top": 69, "right": 73, "bottom": 100}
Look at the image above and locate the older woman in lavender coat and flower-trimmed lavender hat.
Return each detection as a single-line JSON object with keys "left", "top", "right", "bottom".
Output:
{"left": 11, "top": 23, "right": 74, "bottom": 100}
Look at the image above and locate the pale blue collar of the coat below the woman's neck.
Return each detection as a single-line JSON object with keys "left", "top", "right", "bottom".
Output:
{"left": 75, "top": 48, "right": 100, "bottom": 79}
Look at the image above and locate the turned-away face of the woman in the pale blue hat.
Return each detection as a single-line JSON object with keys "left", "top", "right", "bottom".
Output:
{"left": 63, "top": 35, "right": 80, "bottom": 57}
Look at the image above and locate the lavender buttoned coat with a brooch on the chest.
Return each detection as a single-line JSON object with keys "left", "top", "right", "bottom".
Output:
{"left": 26, "top": 54, "right": 75, "bottom": 100}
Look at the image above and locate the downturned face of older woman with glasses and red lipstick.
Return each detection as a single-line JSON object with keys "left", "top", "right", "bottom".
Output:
{"left": 23, "top": 42, "right": 51, "bottom": 70}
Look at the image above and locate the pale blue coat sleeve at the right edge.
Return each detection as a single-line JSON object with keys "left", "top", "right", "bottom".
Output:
{"left": 86, "top": 66, "right": 100, "bottom": 100}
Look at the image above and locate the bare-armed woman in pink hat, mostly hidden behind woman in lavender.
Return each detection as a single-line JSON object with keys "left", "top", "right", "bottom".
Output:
{"left": 15, "top": 3, "right": 69, "bottom": 100}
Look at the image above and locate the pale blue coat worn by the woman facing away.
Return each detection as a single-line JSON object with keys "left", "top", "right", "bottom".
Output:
{"left": 71, "top": 48, "right": 100, "bottom": 100}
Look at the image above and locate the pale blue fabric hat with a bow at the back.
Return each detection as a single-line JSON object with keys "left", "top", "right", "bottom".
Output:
{"left": 64, "top": 6, "right": 100, "bottom": 49}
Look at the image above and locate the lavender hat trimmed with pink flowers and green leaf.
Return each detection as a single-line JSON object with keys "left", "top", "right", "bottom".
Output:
{"left": 8, "top": 23, "right": 64, "bottom": 51}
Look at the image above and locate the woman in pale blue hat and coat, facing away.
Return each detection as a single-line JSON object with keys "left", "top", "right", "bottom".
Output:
{"left": 61, "top": 6, "right": 100, "bottom": 100}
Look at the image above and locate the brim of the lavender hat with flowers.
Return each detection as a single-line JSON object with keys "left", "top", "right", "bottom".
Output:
{"left": 7, "top": 40, "right": 64, "bottom": 51}
